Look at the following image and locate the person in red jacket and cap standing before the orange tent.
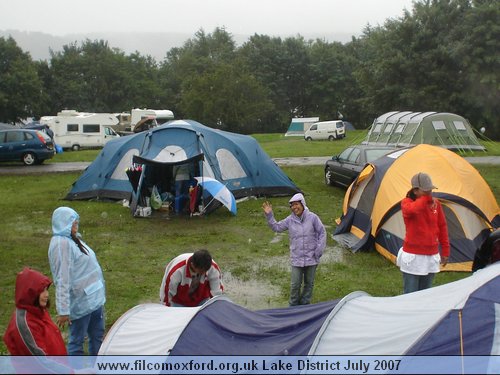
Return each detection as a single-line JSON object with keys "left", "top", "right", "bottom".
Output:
{"left": 396, "top": 173, "right": 450, "bottom": 294}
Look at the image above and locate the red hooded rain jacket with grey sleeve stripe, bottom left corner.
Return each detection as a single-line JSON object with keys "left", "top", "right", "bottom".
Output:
{"left": 3, "top": 268, "right": 67, "bottom": 356}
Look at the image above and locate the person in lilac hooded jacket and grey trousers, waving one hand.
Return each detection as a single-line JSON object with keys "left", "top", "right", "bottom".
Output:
{"left": 262, "top": 193, "right": 326, "bottom": 306}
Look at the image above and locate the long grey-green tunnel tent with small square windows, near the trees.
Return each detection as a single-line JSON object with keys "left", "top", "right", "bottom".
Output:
{"left": 362, "top": 111, "right": 485, "bottom": 151}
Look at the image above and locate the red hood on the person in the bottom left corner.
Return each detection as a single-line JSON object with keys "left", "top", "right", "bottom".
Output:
{"left": 16, "top": 267, "right": 52, "bottom": 312}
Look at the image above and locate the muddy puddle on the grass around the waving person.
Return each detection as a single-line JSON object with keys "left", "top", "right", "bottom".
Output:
{"left": 223, "top": 242, "right": 343, "bottom": 310}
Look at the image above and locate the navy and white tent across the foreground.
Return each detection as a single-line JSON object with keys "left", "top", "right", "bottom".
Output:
{"left": 99, "top": 262, "right": 500, "bottom": 356}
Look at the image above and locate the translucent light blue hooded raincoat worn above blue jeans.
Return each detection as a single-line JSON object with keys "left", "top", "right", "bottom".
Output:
{"left": 49, "top": 207, "right": 106, "bottom": 320}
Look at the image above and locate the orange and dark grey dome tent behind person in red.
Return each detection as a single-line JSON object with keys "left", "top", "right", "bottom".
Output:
{"left": 334, "top": 144, "right": 500, "bottom": 271}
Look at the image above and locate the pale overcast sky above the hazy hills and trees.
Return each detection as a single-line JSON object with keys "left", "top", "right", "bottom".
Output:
{"left": 0, "top": 0, "right": 412, "bottom": 36}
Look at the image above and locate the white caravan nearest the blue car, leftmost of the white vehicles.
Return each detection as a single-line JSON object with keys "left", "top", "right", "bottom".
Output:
{"left": 40, "top": 110, "right": 119, "bottom": 151}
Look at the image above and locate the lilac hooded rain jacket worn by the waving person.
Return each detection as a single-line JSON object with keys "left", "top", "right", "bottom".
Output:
{"left": 266, "top": 193, "right": 326, "bottom": 267}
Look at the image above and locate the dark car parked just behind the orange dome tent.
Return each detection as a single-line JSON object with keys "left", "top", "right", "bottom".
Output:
{"left": 325, "top": 145, "right": 394, "bottom": 188}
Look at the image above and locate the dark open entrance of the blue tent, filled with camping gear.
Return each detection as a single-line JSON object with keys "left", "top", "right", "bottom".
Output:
{"left": 132, "top": 154, "right": 203, "bottom": 217}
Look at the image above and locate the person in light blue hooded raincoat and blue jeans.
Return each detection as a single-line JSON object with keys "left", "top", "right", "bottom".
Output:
{"left": 49, "top": 207, "right": 106, "bottom": 355}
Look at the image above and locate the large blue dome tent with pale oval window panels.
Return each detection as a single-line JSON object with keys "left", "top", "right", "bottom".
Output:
{"left": 66, "top": 120, "right": 300, "bottom": 214}
